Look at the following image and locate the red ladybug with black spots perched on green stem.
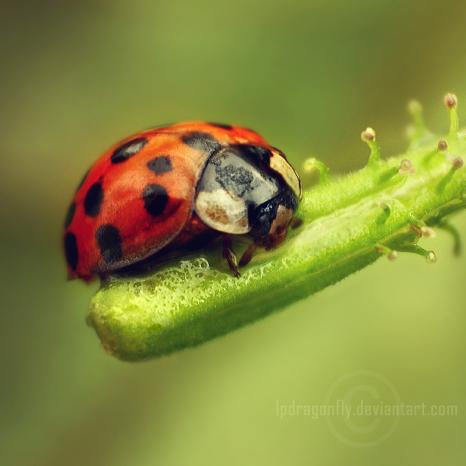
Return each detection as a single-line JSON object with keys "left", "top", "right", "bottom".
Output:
{"left": 64, "top": 122, "right": 301, "bottom": 281}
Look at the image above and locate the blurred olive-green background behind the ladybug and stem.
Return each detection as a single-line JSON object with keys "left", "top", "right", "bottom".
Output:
{"left": 0, "top": 0, "right": 466, "bottom": 466}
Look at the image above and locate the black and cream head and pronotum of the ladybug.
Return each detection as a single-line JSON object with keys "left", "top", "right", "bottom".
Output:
{"left": 195, "top": 144, "right": 301, "bottom": 242}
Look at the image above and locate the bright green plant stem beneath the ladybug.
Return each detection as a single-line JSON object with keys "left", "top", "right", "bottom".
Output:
{"left": 88, "top": 133, "right": 466, "bottom": 360}
